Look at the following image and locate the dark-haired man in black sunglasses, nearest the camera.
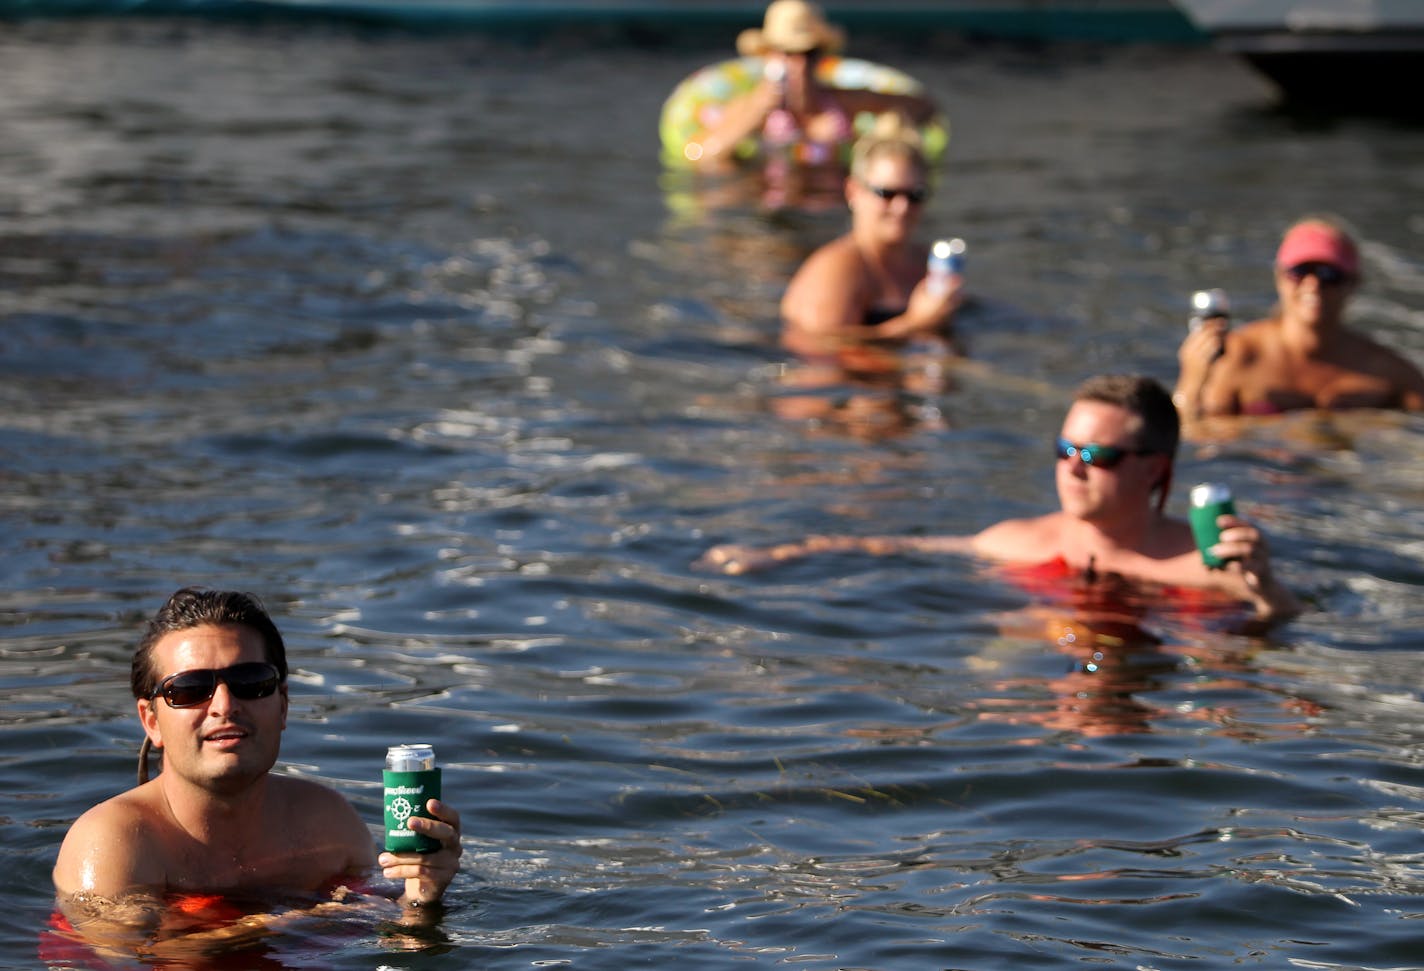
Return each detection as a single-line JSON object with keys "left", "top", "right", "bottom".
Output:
{"left": 54, "top": 588, "right": 461, "bottom": 940}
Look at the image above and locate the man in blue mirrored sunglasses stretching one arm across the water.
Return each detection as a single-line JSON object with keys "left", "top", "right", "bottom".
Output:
{"left": 701, "top": 374, "right": 1300, "bottom": 622}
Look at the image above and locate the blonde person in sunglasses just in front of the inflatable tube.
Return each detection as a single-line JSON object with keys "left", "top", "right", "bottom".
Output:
{"left": 782, "top": 114, "right": 964, "bottom": 355}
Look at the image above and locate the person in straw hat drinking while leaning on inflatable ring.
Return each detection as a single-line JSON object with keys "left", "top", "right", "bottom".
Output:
{"left": 685, "top": 0, "right": 934, "bottom": 167}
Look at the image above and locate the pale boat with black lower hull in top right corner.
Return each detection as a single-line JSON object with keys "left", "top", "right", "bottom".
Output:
{"left": 1176, "top": 0, "right": 1424, "bottom": 114}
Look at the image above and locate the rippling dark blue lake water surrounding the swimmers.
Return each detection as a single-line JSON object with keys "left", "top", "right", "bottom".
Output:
{"left": 8, "top": 13, "right": 1424, "bottom": 971}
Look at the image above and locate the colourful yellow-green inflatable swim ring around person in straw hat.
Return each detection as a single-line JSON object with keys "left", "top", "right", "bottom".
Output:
{"left": 658, "top": 57, "right": 950, "bottom": 165}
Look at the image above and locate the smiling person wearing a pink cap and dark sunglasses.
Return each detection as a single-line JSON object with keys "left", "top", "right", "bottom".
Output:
{"left": 1172, "top": 216, "right": 1424, "bottom": 420}
